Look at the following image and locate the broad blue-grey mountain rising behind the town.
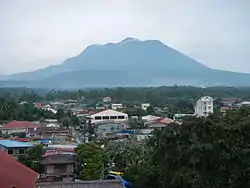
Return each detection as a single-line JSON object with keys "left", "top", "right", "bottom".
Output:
{"left": 0, "top": 38, "right": 250, "bottom": 89}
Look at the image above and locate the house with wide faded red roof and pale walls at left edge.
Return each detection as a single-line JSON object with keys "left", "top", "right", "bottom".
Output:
{"left": 2, "top": 121, "right": 41, "bottom": 134}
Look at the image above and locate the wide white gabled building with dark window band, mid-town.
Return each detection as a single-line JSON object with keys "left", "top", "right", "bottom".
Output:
{"left": 90, "top": 109, "right": 128, "bottom": 123}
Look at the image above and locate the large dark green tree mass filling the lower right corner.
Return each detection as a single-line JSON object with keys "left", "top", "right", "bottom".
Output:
{"left": 105, "top": 109, "right": 250, "bottom": 188}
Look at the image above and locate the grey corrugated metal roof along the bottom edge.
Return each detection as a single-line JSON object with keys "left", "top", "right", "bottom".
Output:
{"left": 36, "top": 180, "right": 123, "bottom": 188}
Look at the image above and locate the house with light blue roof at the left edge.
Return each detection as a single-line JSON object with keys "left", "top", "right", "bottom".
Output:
{"left": 0, "top": 140, "right": 33, "bottom": 157}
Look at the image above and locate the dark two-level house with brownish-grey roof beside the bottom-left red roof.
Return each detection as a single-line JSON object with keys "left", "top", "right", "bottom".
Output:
{"left": 41, "top": 153, "right": 76, "bottom": 180}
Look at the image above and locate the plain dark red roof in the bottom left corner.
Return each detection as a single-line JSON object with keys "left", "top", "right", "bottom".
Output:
{"left": 0, "top": 150, "right": 39, "bottom": 188}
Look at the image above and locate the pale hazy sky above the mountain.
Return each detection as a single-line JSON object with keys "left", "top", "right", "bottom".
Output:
{"left": 0, "top": 0, "right": 250, "bottom": 74}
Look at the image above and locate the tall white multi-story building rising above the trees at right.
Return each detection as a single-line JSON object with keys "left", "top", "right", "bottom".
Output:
{"left": 195, "top": 96, "right": 214, "bottom": 117}
